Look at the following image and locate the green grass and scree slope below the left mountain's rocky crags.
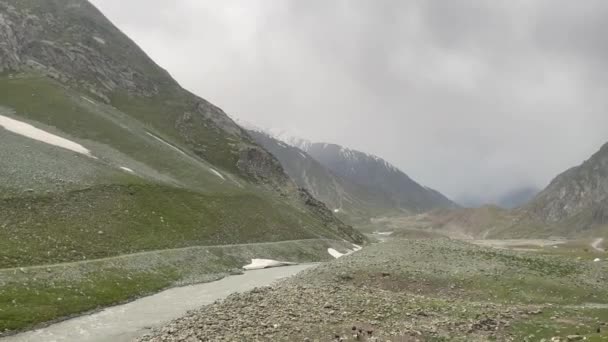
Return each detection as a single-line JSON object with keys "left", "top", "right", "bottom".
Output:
{"left": 0, "top": 75, "right": 358, "bottom": 268}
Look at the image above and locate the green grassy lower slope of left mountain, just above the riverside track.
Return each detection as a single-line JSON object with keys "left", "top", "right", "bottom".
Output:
{"left": 0, "top": 184, "right": 350, "bottom": 268}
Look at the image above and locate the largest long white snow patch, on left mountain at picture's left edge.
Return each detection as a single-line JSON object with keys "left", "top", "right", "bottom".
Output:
{"left": 0, "top": 115, "right": 95, "bottom": 158}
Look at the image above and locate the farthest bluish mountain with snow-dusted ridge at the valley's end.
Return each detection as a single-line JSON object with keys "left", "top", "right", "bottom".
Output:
{"left": 301, "top": 143, "right": 456, "bottom": 213}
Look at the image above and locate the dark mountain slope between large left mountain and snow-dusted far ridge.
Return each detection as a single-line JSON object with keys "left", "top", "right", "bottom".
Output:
{"left": 249, "top": 130, "right": 394, "bottom": 224}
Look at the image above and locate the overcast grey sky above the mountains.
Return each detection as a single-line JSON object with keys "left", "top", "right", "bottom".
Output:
{"left": 93, "top": 0, "right": 608, "bottom": 204}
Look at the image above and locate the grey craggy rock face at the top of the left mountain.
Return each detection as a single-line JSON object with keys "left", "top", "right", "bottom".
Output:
{"left": 0, "top": 0, "right": 166, "bottom": 101}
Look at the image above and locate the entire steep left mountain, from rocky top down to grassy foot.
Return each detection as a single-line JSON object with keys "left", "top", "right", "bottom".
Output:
{"left": 0, "top": 0, "right": 362, "bottom": 268}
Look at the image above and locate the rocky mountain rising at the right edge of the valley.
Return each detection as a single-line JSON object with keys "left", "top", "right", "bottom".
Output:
{"left": 523, "top": 140, "right": 608, "bottom": 234}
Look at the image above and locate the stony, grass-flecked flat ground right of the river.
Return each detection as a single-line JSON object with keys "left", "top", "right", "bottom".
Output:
{"left": 140, "top": 239, "right": 608, "bottom": 342}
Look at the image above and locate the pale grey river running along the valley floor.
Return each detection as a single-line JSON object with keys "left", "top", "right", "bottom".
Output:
{"left": 0, "top": 264, "right": 314, "bottom": 342}
